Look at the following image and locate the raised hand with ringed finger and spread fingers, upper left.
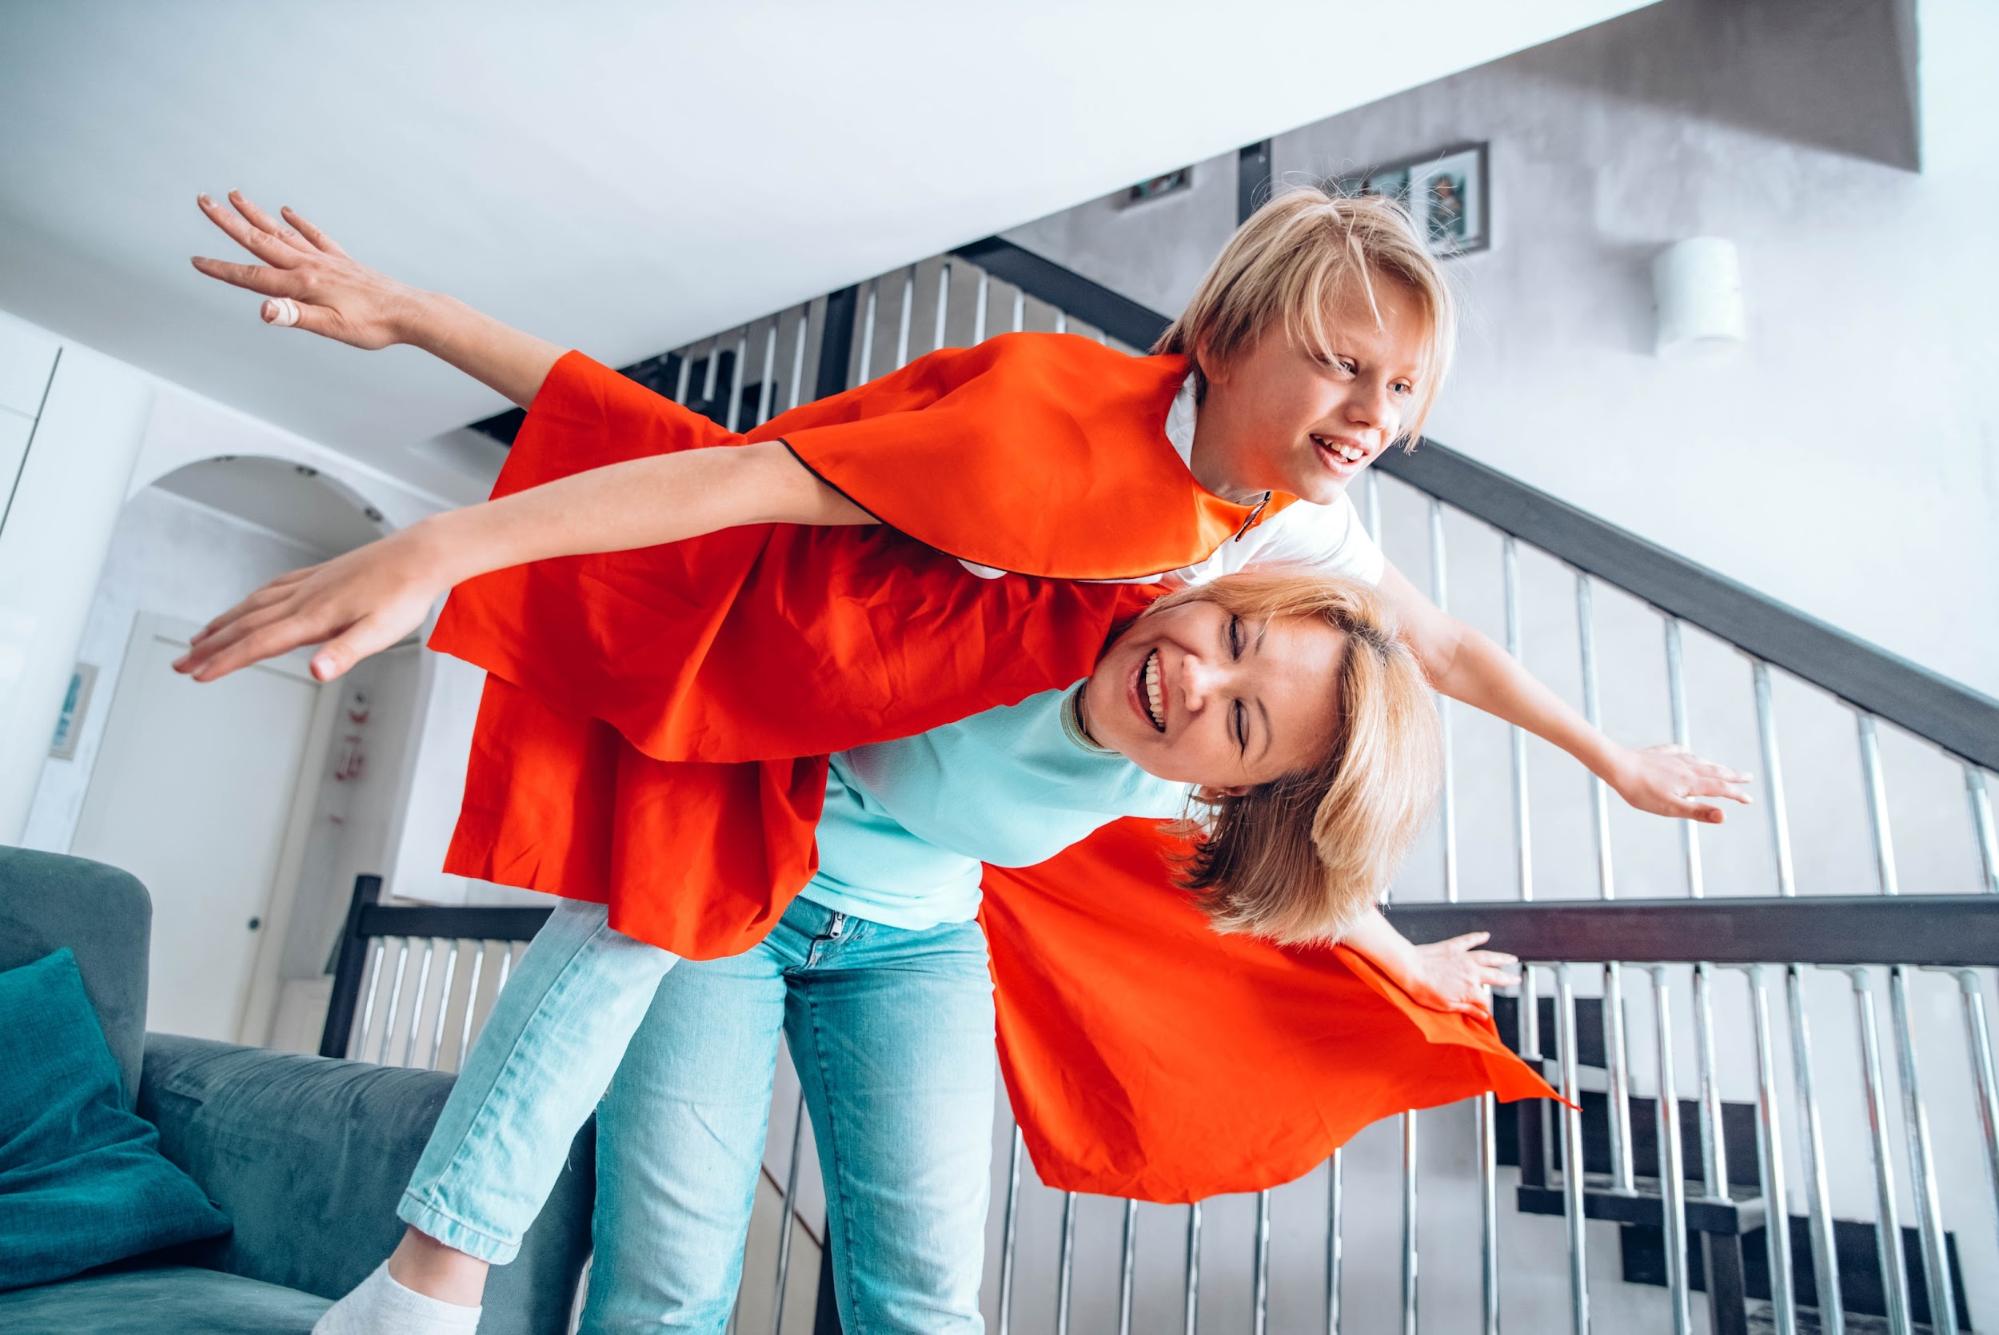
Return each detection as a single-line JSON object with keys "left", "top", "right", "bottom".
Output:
{"left": 194, "top": 190, "right": 424, "bottom": 350}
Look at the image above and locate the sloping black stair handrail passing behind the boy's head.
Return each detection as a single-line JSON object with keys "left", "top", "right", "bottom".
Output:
{"left": 952, "top": 236, "right": 1999, "bottom": 769}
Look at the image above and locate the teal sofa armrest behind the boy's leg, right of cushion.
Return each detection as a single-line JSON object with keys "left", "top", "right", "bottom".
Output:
{"left": 138, "top": 1033, "right": 596, "bottom": 1335}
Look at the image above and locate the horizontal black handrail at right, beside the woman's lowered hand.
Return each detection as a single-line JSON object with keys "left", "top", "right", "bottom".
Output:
{"left": 1387, "top": 895, "right": 1999, "bottom": 969}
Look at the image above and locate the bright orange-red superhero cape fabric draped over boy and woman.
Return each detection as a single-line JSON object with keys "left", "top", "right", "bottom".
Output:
{"left": 430, "top": 334, "right": 1551, "bottom": 1201}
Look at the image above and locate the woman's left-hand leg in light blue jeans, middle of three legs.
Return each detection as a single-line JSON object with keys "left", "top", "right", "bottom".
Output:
{"left": 582, "top": 901, "right": 803, "bottom": 1335}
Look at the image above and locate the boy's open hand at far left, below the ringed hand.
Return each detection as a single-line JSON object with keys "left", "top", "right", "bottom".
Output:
{"left": 174, "top": 524, "right": 452, "bottom": 681}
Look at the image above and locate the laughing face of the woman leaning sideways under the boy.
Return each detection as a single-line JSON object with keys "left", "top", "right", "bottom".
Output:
{"left": 1083, "top": 600, "right": 1347, "bottom": 793}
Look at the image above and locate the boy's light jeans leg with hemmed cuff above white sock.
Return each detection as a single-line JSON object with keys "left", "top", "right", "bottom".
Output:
{"left": 396, "top": 899, "right": 678, "bottom": 1265}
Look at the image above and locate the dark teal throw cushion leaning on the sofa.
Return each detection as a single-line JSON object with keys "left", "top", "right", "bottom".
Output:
{"left": 0, "top": 947, "right": 230, "bottom": 1289}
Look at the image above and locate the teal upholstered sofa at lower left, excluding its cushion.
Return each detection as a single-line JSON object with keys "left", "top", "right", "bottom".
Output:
{"left": 0, "top": 847, "right": 596, "bottom": 1335}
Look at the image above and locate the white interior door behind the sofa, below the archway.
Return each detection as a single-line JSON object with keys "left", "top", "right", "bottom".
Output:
{"left": 70, "top": 614, "right": 326, "bottom": 1039}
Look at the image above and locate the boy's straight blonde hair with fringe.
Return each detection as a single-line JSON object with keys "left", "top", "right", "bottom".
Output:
{"left": 1151, "top": 186, "right": 1457, "bottom": 450}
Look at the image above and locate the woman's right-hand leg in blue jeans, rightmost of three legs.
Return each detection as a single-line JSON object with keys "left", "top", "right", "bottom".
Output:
{"left": 786, "top": 917, "right": 996, "bottom": 1335}
